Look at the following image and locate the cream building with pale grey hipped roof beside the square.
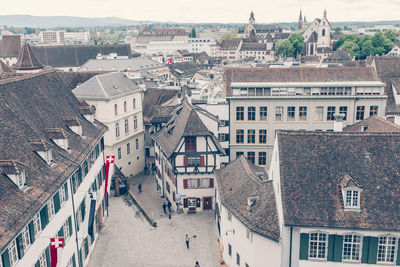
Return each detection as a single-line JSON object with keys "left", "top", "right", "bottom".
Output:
{"left": 73, "top": 72, "right": 145, "bottom": 176}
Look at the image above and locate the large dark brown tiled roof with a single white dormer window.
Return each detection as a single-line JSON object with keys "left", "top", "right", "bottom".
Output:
{"left": 278, "top": 131, "right": 400, "bottom": 231}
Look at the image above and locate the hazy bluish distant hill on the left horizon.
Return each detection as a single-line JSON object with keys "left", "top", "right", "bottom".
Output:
{"left": 0, "top": 15, "right": 152, "bottom": 28}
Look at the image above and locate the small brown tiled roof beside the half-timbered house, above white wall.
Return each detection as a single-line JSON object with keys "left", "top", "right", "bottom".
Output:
{"left": 215, "top": 156, "right": 280, "bottom": 241}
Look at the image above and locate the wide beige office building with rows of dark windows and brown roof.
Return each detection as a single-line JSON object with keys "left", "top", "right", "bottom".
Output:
{"left": 224, "top": 67, "right": 387, "bottom": 166}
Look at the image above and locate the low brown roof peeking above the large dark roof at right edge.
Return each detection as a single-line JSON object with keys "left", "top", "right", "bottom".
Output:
{"left": 343, "top": 116, "right": 400, "bottom": 133}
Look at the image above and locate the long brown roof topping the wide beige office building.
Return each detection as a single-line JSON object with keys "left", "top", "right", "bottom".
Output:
{"left": 224, "top": 67, "right": 380, "bottom": 96}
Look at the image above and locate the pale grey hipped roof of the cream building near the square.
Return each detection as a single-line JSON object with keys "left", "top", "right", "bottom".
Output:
{"left": 72, "top": 72, "right": 142, "bottom": 100}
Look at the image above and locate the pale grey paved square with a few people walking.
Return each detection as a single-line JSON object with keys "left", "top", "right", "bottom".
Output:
{"left": 89, "top": 175, "right": 218, "bottom": 267}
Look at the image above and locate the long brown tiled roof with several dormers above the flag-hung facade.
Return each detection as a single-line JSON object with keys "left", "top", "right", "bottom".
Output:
{"left": 0, "top": 71, "right": 106, "bottom": 251}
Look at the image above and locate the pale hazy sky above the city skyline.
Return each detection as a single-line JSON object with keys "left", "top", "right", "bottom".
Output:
{"left": 0, "top": 0, "right": 400, "bottom": 23}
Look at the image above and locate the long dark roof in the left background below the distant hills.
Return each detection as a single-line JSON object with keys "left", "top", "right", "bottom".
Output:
{"left": 32, "top": 44, "right": 132, "bottom": 68}
